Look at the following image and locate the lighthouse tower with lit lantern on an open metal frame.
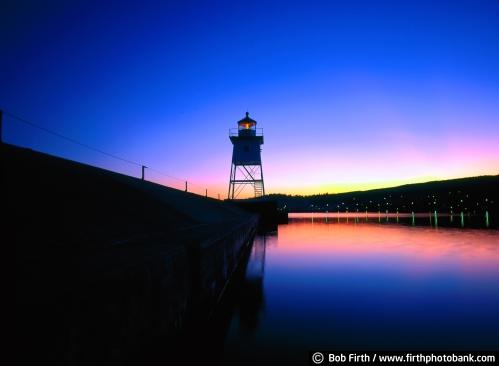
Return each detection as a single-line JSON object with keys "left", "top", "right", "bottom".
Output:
{"left": 228, "top": 112, "right": 265, "bottom": 199}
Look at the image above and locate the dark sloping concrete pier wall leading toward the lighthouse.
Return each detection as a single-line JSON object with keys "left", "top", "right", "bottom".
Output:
{"left": 2, "top": 144, "right": 258, "bottom": 365}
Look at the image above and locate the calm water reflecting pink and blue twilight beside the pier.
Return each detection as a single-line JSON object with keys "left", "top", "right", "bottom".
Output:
{"left": 222, "top": 214, "right": 499, "bottom": 364}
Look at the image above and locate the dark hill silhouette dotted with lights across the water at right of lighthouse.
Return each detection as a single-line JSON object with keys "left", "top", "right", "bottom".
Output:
{"left": 260, "top": 175, "right": 499, "bottom": 214}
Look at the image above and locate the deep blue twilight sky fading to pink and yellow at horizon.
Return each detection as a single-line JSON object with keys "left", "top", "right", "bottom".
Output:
{"left": 0, "top": 0, "right": 499, "bottom": 197}
